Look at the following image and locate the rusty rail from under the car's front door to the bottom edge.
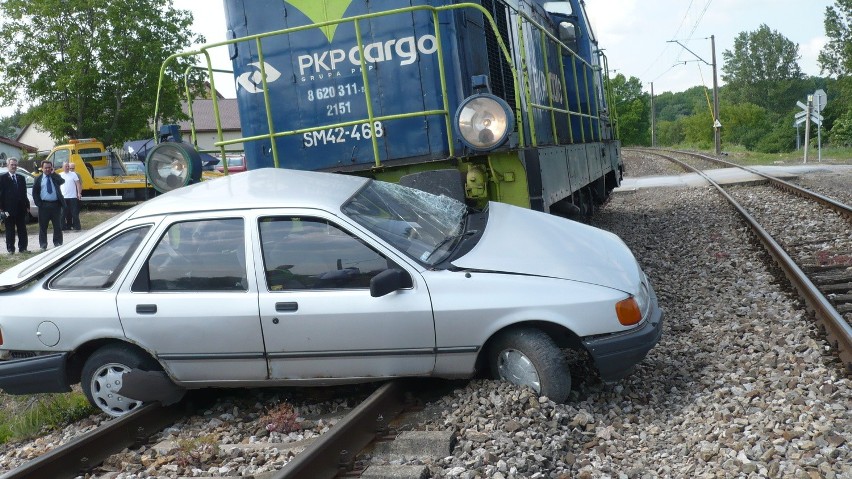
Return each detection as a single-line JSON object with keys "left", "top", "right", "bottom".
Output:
{"left": 270, "top": 381, "right": 406, "bottom": 479}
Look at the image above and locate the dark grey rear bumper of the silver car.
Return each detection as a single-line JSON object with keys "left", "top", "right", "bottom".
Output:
{"left": 0, "top": 353, "right": 71, "bottom": 394}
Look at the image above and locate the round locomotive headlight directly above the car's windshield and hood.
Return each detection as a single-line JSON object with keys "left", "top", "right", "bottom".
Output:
{"left": 455, "top": 93, "right": 515, "bottom": 151}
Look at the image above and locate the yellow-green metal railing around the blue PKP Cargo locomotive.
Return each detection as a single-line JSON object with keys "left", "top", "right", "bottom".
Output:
{"left": 154, "top": 3, "right": 616, "bottom": 168}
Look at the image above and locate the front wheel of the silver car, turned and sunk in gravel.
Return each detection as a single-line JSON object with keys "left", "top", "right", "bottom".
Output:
{"left": 488, "top": 328, "right": 571, "bottom": 403}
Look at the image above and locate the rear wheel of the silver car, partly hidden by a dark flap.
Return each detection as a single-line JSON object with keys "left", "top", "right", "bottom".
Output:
{"left": 80, "top": 345, "right": 162, "bottom": 417}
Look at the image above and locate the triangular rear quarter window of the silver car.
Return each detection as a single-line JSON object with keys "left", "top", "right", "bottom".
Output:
{"left": 50, "top": 226, "right": 151, "bottom": 289}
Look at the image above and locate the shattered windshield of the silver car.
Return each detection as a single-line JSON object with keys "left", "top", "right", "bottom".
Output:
{"left": 341, "top": 181, "right": 467, "bottom": 265}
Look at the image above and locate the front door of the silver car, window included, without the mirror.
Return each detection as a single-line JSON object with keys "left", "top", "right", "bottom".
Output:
{"left": 255, "top": 212, "right": 435, "bottom": 383}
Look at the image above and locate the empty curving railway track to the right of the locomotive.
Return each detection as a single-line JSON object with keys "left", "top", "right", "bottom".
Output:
{"left": 628, "top": 149, "right": 852, "bottom": 372}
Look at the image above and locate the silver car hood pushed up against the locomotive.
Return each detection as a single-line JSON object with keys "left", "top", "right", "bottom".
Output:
{"left": 451, "top": 202, "right": 642, "bottom": 294}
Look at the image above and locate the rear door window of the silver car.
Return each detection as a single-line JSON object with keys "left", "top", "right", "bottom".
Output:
{"left": 139, "top": 218, "right": 248, "bottom": 292}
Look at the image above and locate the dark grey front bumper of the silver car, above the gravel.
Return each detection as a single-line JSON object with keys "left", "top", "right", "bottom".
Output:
{"left": 583, "top": 289, "right": 663, "bottom": 383}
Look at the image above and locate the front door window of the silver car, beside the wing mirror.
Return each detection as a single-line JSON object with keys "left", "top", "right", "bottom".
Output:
{"left": 260, "top": 217, "right": 401, "bottom": 291}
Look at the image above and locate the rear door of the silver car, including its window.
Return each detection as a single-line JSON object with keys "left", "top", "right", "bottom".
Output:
{"left": 117, "top": 216, "right": 268, "bottom": 384}
